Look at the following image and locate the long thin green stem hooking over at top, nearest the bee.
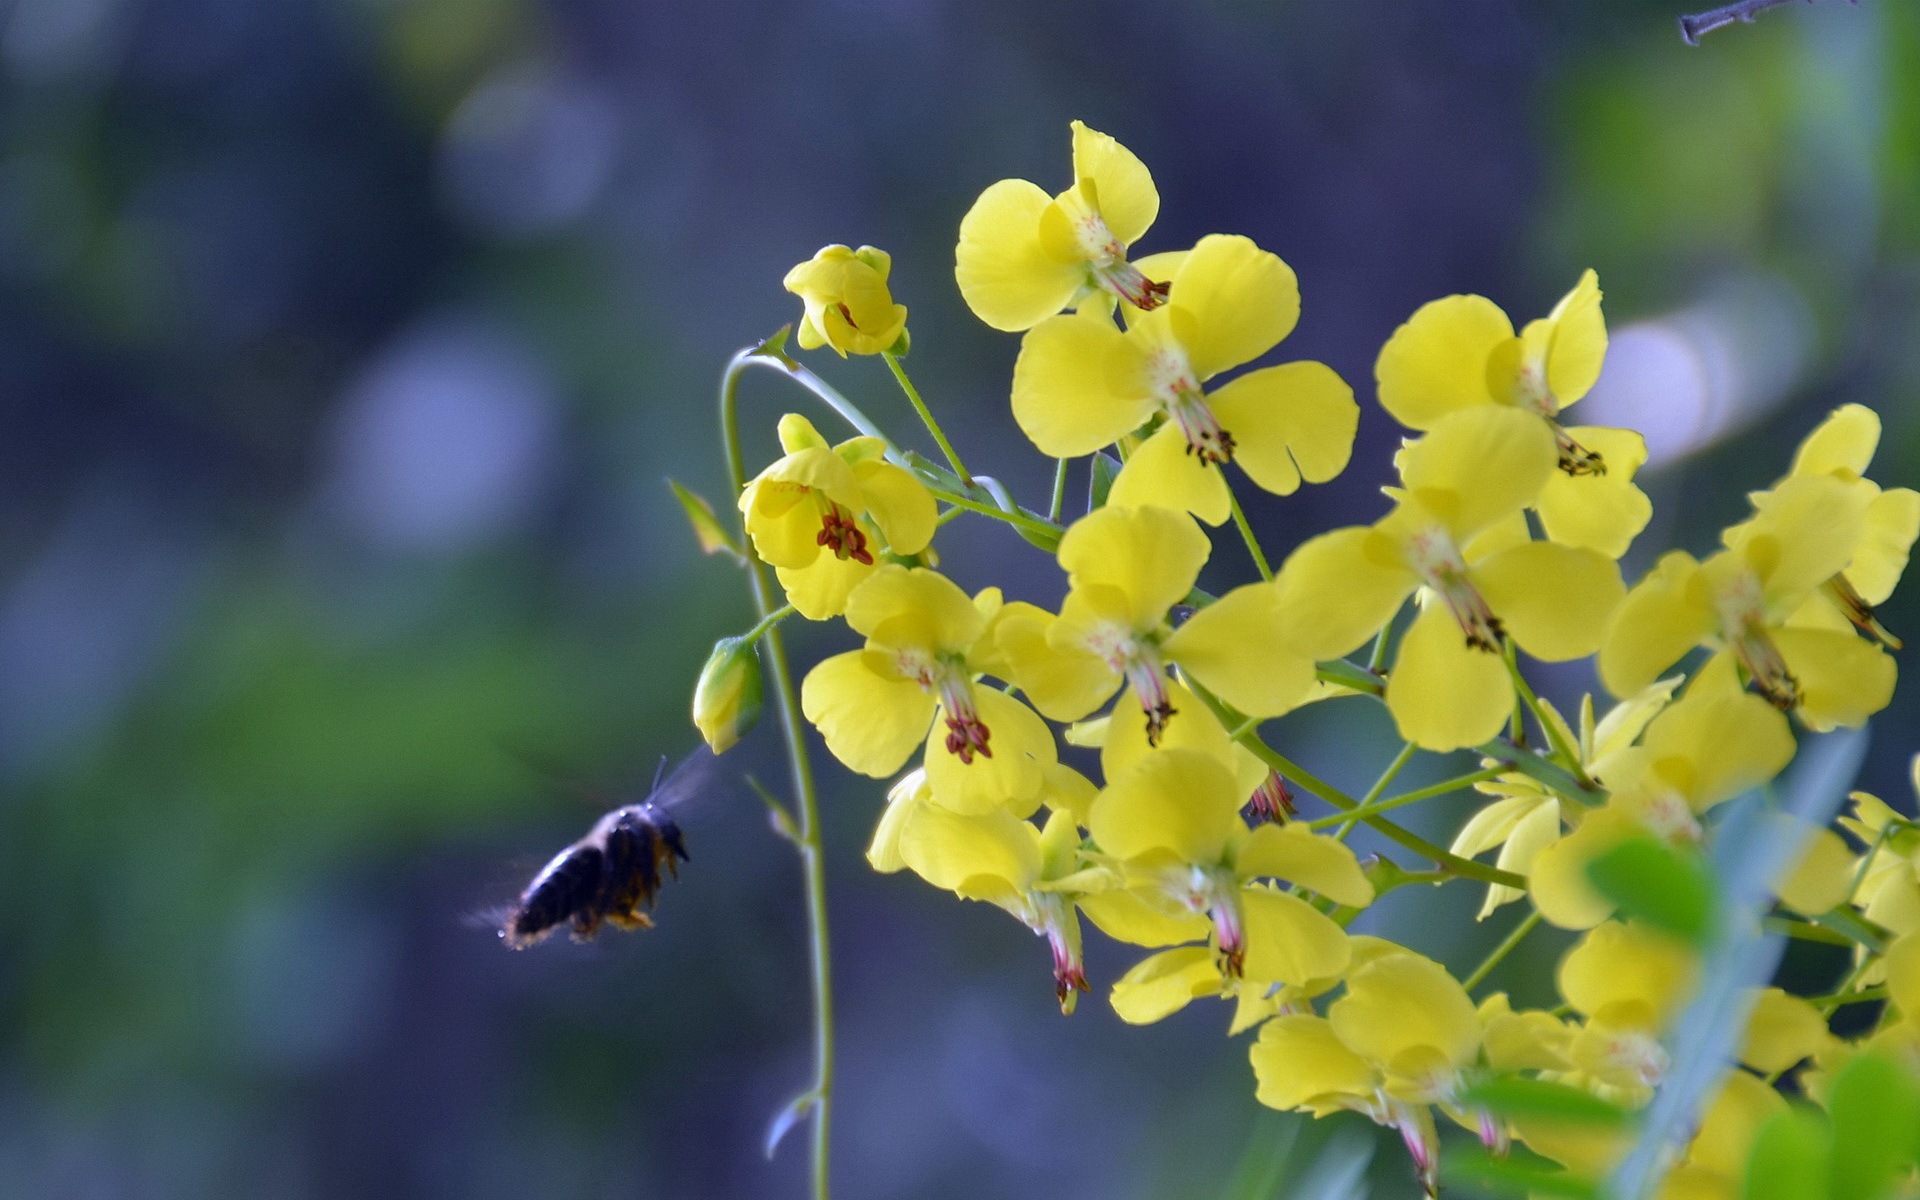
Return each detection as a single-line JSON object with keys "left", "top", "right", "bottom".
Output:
{"left": 720, "top": 349, "right": 833, "bottom": 1200}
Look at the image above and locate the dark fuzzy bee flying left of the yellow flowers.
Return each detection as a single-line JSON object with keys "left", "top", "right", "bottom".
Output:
{"left": 499, "top": 753, "right": 712, "bottom": 950}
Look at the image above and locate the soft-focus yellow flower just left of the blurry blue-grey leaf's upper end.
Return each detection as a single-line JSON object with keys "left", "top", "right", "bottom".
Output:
{"left": 1528, "top": 680, "right": 1793, "bottom": 929}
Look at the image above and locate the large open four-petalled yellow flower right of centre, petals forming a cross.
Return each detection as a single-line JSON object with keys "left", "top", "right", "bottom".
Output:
{"left": 1279, "top": 405, "right": 1622, "bottom": 751}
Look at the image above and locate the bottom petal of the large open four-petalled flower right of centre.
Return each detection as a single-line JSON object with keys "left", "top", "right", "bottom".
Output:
{"left": 1386, "top": 601, "right": 1513, "bottom": 751}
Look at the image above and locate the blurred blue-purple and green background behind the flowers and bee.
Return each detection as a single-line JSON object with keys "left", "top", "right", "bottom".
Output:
{"left": 0, "top": 0, "right": 1920, "bottom": 1200}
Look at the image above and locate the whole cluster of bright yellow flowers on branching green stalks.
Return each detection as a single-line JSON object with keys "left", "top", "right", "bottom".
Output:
{"left": 702, "top": 123, "right": 1920, "bottom": 1196}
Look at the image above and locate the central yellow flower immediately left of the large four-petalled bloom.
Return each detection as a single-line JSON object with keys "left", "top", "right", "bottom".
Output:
{"left": 996, "top": 505, "right": 1313, "bottom": 745}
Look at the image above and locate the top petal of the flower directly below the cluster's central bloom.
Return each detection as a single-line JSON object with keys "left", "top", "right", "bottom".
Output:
{"left": 1087, "top": 749, "right": 1246, "bottom": 864}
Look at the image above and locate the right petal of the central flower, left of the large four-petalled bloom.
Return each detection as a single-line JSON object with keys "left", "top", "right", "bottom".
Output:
{"left": 1164, "top": 584, "right": 1313, "bottom": 716}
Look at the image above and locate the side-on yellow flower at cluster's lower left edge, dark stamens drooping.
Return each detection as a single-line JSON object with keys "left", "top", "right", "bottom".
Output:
{"left": 868, "top": 772, "right": 1112, "bottom": 1014}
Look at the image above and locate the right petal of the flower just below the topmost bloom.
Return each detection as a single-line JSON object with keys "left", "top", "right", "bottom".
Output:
{"left": 1206, "top": 363, "right": 1359, "bottom": 495}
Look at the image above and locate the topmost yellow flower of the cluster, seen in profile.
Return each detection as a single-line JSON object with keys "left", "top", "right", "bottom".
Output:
{"left": 954, "top": 121, "right": 1167, "bottom": 332}
